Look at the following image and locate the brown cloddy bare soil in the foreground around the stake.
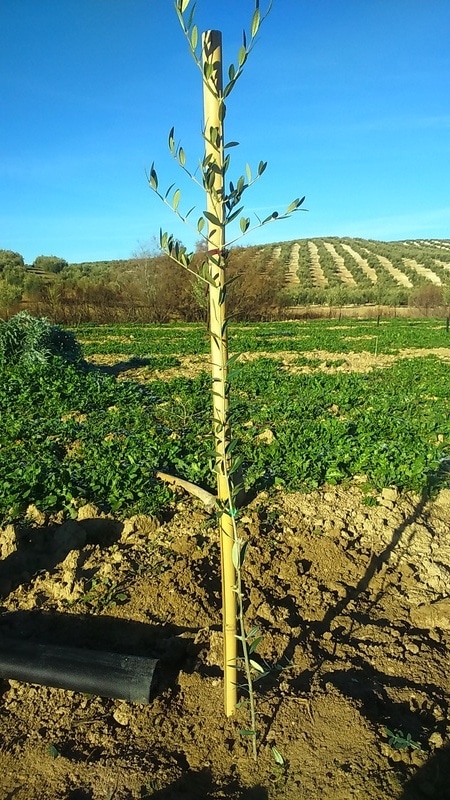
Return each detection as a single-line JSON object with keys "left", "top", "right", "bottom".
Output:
{"left": 0, "top": 483, "right": 450, "bottom": 800}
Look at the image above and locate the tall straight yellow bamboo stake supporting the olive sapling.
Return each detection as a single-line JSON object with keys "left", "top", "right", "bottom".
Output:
{"left": 202, "top": 31, "right": 237, "bottom": 716}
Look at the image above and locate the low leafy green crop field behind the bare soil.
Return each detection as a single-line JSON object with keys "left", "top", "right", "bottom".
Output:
{"left": 0, "top": 319, "right": 450, "bottom": 521}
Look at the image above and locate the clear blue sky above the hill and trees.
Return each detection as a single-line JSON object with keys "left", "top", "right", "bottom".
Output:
{"left": 0, "top": 0, "right": 450, "bottom": 263}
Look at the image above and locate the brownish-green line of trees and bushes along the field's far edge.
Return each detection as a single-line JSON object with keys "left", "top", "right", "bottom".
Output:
{"left": 0, "top": 245, "right": 450, "bottom": 324}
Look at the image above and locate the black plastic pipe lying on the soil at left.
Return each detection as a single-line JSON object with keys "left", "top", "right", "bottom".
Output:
{"left": 0, "top": 636, "right": 158, "bottom": 703}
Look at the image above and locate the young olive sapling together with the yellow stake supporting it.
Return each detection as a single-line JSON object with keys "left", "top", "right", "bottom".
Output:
{"left": 148, "top": 0, "right": 304, "bottom": 728}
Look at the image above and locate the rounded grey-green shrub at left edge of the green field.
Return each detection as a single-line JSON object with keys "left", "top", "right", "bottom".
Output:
{"left": 0, "top": 311, "right": 82, "bottom": 367}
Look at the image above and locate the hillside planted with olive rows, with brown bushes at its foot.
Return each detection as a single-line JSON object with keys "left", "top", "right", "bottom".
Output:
{"left": 14, "top": 237, "right": 450, "bottom": 324}
